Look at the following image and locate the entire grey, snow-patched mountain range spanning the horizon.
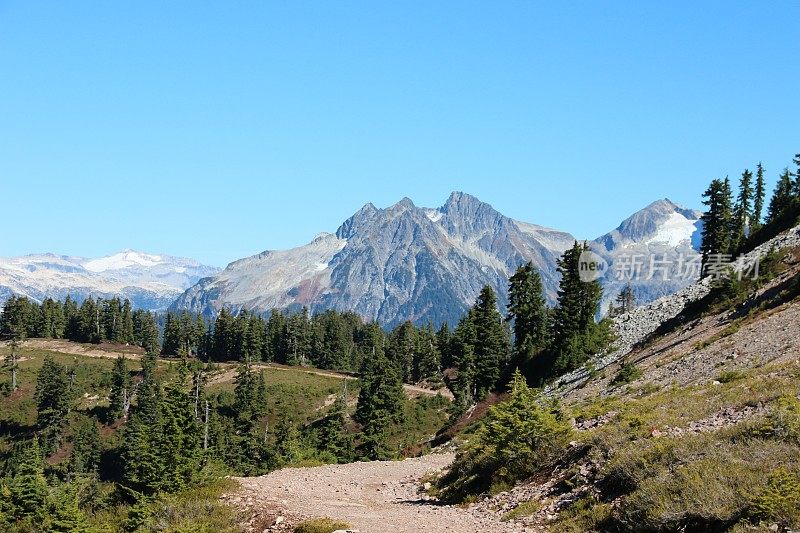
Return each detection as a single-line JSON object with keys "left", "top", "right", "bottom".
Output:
{"left": 0, "top": 192, "right": 701, "bottom": 327}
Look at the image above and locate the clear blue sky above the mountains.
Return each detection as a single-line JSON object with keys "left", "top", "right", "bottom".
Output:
{"left": 0, "top": 0, "right": 800, "bottom": 266}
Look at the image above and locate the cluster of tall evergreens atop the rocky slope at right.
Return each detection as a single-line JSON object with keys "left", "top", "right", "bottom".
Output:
{"left": 701, "top": 154, "right": 800, "bottom": 272}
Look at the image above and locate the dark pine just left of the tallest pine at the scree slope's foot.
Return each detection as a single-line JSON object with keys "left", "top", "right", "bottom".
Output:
{"left": 506, "top": 262, "right": 548, "bottom": 363}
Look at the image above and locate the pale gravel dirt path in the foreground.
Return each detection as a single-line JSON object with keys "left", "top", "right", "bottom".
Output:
{"left": 225, "top": 453, "right": 525, "bottom": 533}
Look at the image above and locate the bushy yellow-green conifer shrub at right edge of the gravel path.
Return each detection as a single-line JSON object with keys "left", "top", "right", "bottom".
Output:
{"left": 438, "top": 372, "right": 572, "bottom": 501}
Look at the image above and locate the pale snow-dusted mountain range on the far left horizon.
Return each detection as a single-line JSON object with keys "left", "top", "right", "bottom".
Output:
{"left": 0, "top": 250, "right": 220, "bottom": 310}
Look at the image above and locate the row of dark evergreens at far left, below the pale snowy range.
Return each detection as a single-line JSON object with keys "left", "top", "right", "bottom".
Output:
{"left": 0, "top": 296, "right": 160, "bottom": 351}
